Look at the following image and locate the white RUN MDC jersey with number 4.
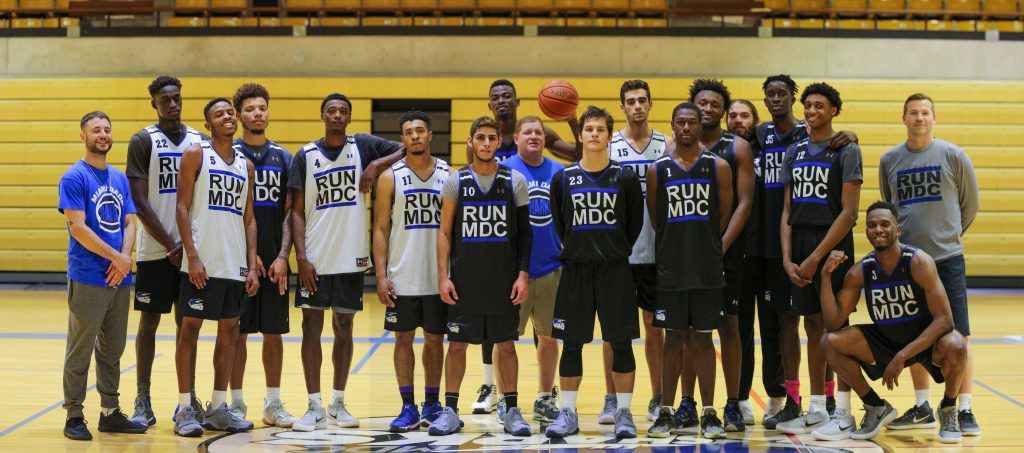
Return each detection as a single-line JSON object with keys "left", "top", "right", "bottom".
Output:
{"left": 302, "top": 135, "right": 370, "bottom": 276}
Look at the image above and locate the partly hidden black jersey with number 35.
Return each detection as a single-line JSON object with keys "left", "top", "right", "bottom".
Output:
{"left": 754, "top": 121, "right": 807, "bottom": 258}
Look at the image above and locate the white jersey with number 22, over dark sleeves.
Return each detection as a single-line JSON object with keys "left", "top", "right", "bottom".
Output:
{"left": 136, "top": 124, "right": 203, "bottom": 261}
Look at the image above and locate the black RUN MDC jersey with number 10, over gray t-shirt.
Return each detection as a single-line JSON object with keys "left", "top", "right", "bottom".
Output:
{"left": 451, "top": 165, "right": 519, "bottom": 314}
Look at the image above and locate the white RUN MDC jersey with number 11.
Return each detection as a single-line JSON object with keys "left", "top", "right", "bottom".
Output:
{"left": 387, "top": 158, "right": 449, "bottom": 296}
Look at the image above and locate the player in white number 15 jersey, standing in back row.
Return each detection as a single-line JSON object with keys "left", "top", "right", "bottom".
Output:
{"left": 597, "top": 80, "right": 672, "bottom": 423}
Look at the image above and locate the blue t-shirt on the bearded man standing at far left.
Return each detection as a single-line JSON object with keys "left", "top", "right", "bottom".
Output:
{"left": 57, "top": 161, "right": 135, "bottom": 286}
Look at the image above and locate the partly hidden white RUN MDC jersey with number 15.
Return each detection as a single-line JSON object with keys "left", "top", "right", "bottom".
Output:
{"left": 608, "top": 130, "right": 668, "bottom": 264}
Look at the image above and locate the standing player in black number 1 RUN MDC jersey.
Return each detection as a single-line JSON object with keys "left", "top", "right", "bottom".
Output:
{"left": 646, "top": 102, "right": 729, "bottom": 439}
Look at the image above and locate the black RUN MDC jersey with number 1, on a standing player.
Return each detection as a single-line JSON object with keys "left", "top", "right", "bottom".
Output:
{"left": 654, "top": 153, "right": 725, "bottom": 291}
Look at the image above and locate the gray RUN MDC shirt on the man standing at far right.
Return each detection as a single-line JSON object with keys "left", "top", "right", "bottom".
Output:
{"left": 879, "top": 138, "right": 980, "bottom": 261}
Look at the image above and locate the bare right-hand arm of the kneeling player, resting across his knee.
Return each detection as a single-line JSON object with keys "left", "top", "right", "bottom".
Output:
{"left": 882, "top": 250, "right": 953, "bottom": 389}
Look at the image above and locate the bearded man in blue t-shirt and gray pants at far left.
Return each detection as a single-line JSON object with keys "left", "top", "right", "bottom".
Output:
{"left": 57, "top": 112, "right": 148, "bottom": 441}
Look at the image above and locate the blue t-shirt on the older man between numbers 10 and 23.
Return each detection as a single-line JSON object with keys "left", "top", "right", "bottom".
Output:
{"left": 501, "top": 155, "right": 564, "bottom": 279}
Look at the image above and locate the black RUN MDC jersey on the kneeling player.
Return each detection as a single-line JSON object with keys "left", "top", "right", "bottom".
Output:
{"left": 860, "top": 245, "right": 932, "bottom": 344}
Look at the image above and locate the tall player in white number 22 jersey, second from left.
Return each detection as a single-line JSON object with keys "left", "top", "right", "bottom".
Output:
{"left": 125, "top": 76, "right": 207, "bottom": 425}
